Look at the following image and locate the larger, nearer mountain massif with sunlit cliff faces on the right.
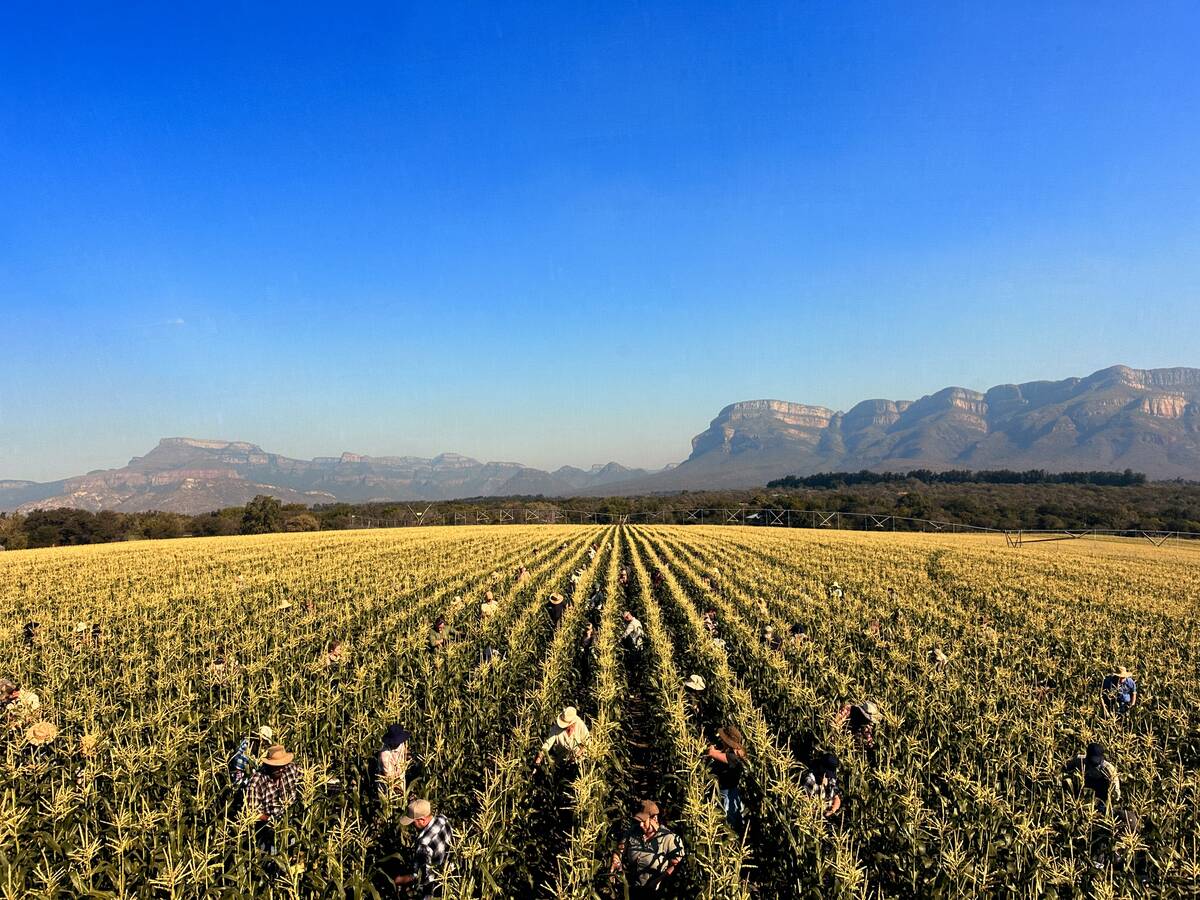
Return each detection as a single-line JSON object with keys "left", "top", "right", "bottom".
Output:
{"left": 595, "top": 366, "right": 1200, "bottom": 493}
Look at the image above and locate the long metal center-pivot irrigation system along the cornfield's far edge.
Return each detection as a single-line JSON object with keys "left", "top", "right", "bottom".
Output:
{"left": 340, "top": 504, "right": 1200, "bottom": 548}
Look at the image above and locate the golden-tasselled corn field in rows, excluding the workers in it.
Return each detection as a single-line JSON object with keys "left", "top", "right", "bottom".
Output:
{"left": 0, "top": 526, "right": 1200, "bottom": 900}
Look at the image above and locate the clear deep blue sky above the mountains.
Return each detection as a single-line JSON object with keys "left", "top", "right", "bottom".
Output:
{"left": 0, "top": 2, "right": 1200, "bottom": 479}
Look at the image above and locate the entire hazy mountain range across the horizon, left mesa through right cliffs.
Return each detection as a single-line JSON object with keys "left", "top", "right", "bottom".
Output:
{"left": 0, "top": 366, "right": 1200, "bottom": 514}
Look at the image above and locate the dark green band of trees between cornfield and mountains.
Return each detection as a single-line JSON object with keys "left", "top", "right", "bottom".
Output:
{"left": 0, "top": 472, "right": 1200, "bottom": 550}
